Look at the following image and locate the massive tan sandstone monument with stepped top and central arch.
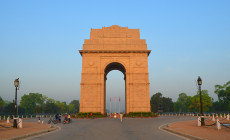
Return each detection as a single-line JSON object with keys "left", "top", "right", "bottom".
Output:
{"left": 79, "top": 25, "right": 151, "bottom": 114}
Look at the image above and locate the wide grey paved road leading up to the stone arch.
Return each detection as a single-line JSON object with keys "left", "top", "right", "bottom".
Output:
{"left": 26, "top": 117, "right": 196, "bottom": 140}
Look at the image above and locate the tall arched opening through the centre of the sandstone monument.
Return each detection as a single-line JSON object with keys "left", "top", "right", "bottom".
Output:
{"left": 104, "top": 62, "right": 126, "bottom": 113}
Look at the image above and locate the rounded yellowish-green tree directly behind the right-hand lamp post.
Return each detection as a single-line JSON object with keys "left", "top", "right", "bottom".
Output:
{"left": 189, "top": 90, "right": 212, "bottom": 112}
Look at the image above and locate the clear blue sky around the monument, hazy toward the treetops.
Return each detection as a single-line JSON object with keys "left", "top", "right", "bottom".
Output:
{"left": 0, "top": 0, "right": 230, "bottom": 111}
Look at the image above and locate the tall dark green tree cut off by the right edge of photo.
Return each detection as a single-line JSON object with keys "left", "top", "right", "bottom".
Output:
{"left": 215, "top": 81, "right": 230, "bottom": 111}
